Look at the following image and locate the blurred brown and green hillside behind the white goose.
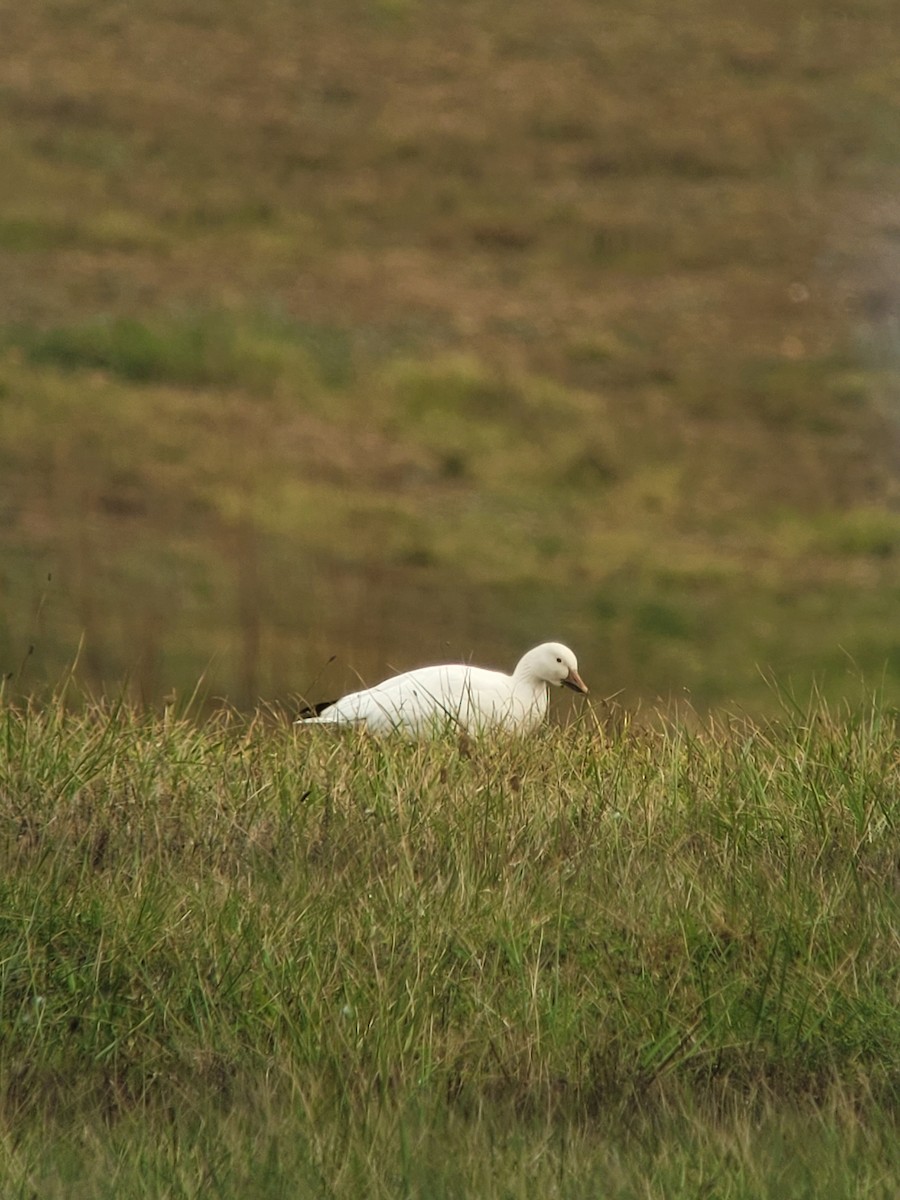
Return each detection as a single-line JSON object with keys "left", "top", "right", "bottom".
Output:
{"left": 0, "top": 0, "right": 900, "bottom": 712}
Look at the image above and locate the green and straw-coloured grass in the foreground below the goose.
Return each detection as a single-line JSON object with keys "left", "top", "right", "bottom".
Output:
{"left": 0, "top": 696, "right": 900, "bottom": 1200}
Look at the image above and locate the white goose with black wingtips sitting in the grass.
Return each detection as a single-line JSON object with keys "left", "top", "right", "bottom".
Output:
{"left": 298, "top": 642, "right": 588, "bottom": 734}
